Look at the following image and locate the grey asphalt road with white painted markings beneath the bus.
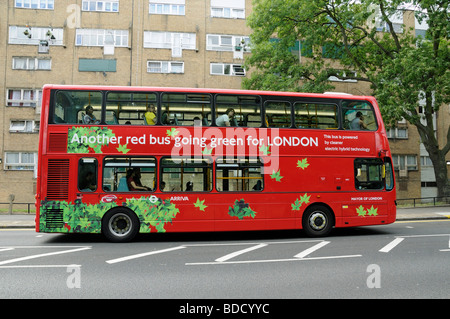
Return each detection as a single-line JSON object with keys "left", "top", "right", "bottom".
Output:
{"left": 0, "top": 220, "right": 450, "bottom": 302}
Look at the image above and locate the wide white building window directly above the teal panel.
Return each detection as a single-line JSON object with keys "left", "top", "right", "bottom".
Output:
{"left": 75, "top": 29, "right": 128, "bottom": 47}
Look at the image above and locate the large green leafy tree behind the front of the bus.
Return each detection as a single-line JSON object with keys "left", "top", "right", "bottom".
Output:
{"left": 243, "top": 0, "right": 450, "bottom": 196}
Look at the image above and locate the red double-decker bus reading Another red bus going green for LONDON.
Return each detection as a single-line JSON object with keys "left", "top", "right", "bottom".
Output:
{"left": 36, "top": 85, "right": 396, "bottom": 242}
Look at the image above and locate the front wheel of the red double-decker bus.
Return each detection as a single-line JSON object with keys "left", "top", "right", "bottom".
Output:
{"left": 302, "top": 205, "right": 334, "bottom": 237}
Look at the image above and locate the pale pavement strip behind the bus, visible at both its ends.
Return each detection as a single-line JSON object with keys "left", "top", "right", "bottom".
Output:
{"left": 0, "top": 206, "right": 450, "bottom": 229}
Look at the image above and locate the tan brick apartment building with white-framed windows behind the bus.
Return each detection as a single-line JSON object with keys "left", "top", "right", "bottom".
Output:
{"left": 0, "top": 0, "right": 450, "bottom": 202}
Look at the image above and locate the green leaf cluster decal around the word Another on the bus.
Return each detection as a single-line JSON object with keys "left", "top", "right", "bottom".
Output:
{"left": 67, "top": 126, "right": 116, "bottom": 153}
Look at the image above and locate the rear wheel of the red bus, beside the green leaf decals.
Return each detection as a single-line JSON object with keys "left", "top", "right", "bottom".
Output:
{"left": 102, "top": 207, "right": 140, "bottom": 243}
